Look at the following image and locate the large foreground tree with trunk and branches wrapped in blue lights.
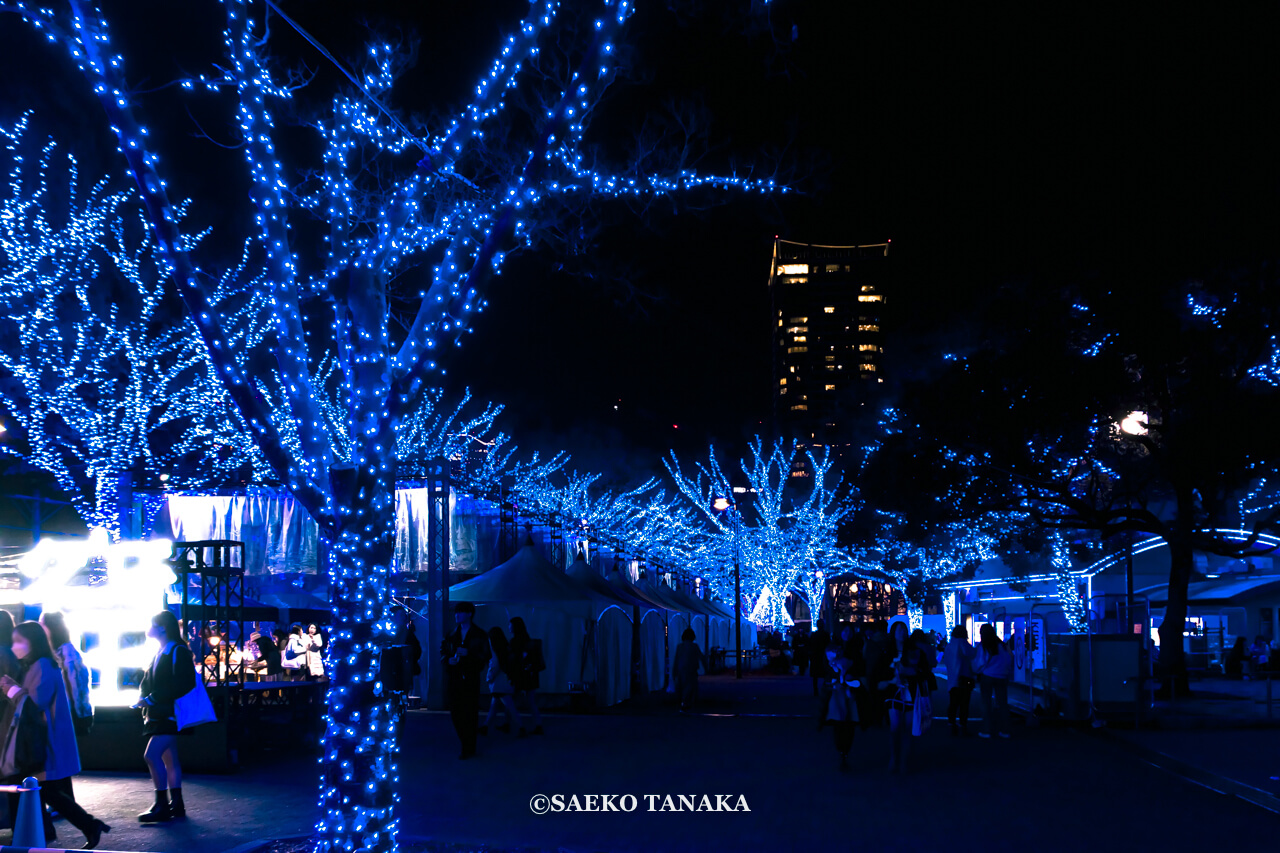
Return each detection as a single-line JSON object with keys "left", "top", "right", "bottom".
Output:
{"left": 0, "top": 0, "right": 774, "bottom": 852}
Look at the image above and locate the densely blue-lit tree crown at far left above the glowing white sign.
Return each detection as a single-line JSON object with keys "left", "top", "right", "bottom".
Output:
{"left": 0, "top": 117, "right": 225, "bottom": 539}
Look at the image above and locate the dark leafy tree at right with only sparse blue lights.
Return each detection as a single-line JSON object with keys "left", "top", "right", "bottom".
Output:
{"left": 931, "top": 272, "right": 1280, "bottom": 686}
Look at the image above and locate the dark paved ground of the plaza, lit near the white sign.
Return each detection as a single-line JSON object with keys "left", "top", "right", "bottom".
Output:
{"left": 0, "top": 676, "right": 1280, "bottom": 853}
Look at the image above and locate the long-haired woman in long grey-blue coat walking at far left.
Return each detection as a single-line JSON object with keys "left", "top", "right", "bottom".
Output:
{"left": 0, "top": 622, "right": 111, "bottom": 850}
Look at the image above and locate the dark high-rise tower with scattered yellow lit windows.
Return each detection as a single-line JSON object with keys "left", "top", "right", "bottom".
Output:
{"left": 769, "top": 238, "right": 890, "bottom": 444}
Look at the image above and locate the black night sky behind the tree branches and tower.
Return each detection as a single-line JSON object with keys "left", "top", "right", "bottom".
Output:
{"left": 0, "top": 0, "right": 1280, "bottom": 474}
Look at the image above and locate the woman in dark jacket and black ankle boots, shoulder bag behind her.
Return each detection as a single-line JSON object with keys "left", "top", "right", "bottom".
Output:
{"left": 133, "top": 610, "right": 196, "bottom": 824}
